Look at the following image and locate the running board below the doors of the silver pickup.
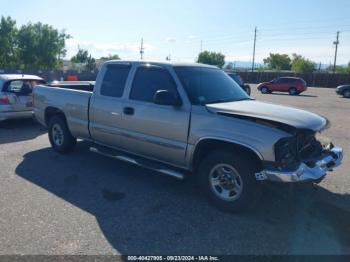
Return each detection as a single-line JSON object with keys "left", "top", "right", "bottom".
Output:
{"left": 90, "top": 146, "right": 185, "bottom": 180}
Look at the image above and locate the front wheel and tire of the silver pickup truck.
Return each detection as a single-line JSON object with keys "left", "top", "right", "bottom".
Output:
{"left": 197, "top": 151, "right": 262, "bottom": 213}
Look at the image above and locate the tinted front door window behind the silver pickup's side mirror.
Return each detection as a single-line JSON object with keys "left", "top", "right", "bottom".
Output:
{"left": 130, "top": 66, "right": 177, "bottom": 103}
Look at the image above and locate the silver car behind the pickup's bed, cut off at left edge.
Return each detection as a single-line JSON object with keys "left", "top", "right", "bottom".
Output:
{"left": 0, "top": 74, "right": 45, "bottom": 121}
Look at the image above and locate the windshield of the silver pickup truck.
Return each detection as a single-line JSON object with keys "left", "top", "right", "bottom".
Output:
{"left": 174, "top": 67, "right": 250, "bottom": 105}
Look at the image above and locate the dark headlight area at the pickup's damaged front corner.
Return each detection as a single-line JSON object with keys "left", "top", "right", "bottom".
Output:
{"left": 275, "top": 137, "right": 296, "bottom": 166}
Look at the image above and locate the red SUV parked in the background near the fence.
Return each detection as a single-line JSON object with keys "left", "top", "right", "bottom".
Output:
{"left": 258, "top": 77, "right": 307, "bottom": 95}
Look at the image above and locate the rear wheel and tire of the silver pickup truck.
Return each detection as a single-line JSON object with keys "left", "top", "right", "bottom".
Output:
{"left": 48, "top": 116, "right": 77, "bottom": 154}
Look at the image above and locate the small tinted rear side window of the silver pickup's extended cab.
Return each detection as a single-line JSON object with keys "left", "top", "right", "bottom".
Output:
{"left": 101, "top": 64, "right": 131, "bottom": 97}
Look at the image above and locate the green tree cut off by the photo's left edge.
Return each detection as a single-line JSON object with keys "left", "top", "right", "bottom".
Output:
{"left": 0, "top": 16, "right": 18, "bottom": 68}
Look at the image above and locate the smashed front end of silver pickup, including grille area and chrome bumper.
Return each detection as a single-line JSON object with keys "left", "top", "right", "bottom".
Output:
{"left": 255, "top": 130, "right": 343, "bottom": 182}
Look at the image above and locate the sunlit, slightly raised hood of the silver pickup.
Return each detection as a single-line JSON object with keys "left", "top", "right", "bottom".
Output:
{"left": 206, "top": 100, "right": 328, "bottom": 132}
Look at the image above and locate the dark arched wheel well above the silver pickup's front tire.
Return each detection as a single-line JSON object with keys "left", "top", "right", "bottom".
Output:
{"left": 192, "top": 139, "right": 262, "bottom": 170}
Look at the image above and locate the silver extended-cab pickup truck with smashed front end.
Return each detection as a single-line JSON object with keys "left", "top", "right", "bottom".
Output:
{"left": 34, "top": 61, "right": 343, "bottom": 212}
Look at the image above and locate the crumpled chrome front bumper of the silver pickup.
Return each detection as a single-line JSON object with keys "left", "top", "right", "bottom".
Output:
{"left": 255, "top": 147, "right": 343, "bottom": 182}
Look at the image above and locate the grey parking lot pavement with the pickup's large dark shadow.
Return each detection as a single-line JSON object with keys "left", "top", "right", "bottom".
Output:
{"left": 0, "top": 85, "right": 350, "bottom": 255}
